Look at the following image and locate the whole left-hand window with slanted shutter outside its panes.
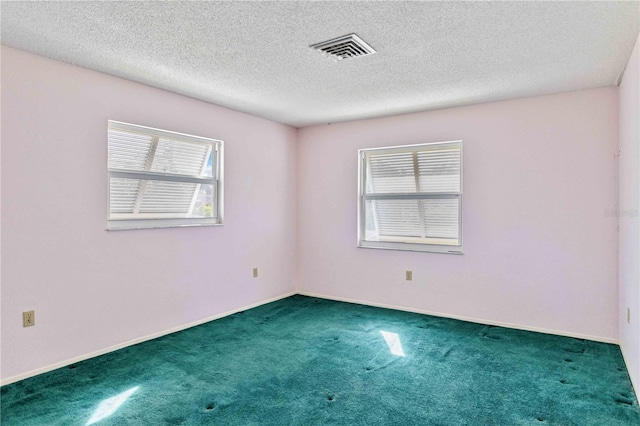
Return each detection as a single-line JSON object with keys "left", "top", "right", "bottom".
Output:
{"left": 107, "top": 120, "right": 223, "bottom": 230}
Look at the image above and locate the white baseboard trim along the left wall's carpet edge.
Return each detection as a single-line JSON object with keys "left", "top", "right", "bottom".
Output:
{"left": 0, "top": 291, "right": 296, "bottom": 386}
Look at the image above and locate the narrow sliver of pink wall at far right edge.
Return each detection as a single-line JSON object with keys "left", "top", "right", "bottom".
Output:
{"left": 619, "top": 37, "right": 640, "bottom": 393}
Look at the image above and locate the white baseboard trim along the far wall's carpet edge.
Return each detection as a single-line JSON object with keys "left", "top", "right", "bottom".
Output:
{"left": 298, "top": 291, "right": 619, "bottom": 345}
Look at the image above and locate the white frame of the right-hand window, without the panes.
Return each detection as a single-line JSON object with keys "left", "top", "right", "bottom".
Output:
{"left": 357, "top": 140, "right": 463, "bottom": 254}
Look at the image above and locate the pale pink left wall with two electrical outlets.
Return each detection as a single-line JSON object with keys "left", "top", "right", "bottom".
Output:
{"left": 1, "top": 47, "right": 297, "bottom": 379}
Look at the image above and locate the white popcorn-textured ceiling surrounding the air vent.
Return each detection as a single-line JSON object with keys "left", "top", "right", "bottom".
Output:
{"left": 1, "top": 1, "right": 639, "bottom": 127}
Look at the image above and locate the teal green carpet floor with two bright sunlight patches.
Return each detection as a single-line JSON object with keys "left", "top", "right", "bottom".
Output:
{"left": 1, "top": 296, "right": 640, "bottom": 426}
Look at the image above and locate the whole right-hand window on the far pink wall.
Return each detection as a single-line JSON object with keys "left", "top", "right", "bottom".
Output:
{"left": 358, "top": 141, "right": 462, "bottom": 254}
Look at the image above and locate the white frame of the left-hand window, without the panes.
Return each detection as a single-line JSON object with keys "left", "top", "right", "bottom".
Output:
{"left": 107, "top": 120, "right": 224, "bottom": 231}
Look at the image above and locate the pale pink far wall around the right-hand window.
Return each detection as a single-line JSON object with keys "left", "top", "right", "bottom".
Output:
{"left": 298, "top": 87, "right": 618, "bottom": 341}
